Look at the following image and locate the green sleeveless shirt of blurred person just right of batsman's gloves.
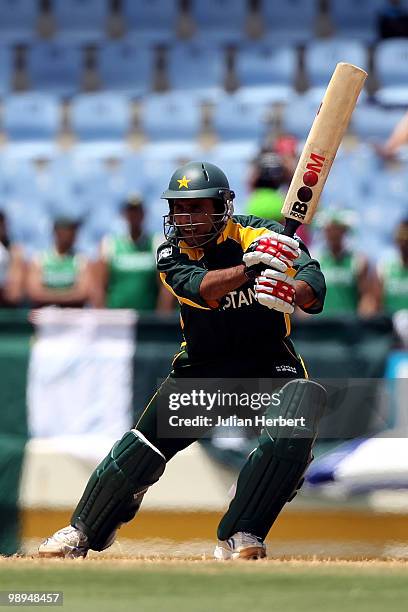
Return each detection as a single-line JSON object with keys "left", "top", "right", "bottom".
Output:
{"left": 318, "top": 251, "right": 361, "bottom": 315}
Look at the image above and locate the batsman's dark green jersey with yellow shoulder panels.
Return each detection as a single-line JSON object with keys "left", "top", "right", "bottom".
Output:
{"left": 157, "top": 215, "right": 326, "bottom": 362}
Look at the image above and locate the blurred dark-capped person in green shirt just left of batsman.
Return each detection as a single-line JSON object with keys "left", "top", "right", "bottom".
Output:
{"left": 91, "top": 195, "right": 174, "bottom": 312}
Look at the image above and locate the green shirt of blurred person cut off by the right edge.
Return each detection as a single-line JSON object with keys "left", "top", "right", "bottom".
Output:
{"left": 378, "top": 254, "right": 408, "bottom": 314}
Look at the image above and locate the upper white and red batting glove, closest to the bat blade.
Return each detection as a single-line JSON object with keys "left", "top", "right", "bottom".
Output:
{"left": 242, "top": 232, "right": 300, "bottom": 272}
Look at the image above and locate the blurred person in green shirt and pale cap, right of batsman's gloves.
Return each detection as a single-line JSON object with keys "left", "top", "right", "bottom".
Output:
{"left": 316, "top": 211, "right": 376, "bottom": 315}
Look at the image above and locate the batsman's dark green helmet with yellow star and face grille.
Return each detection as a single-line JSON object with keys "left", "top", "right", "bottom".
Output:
{"left": 161, "top": 162, "right": 235, "bottom": 248}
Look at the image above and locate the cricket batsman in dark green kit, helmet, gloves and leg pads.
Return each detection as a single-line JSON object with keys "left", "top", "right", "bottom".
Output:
{"left": 39, "top": 162, "right": 326, "bottom": 560}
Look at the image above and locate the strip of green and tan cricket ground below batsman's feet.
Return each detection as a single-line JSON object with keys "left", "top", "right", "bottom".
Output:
{"left": 0, "top": 557, "right": 408, "bottom": 612}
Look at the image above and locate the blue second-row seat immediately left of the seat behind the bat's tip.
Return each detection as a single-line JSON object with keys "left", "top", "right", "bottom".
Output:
{"left": 235, "top": 45, "right": 297, "bottom": 104}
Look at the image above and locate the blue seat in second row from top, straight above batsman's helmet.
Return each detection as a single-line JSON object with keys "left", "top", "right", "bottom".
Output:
{"left": 167, "top": 42, "right": 226, "bottom": 101}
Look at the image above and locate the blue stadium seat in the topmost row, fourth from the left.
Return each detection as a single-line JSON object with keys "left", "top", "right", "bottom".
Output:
{"left": 191, "top": 0, "right": 248, "bottom": 44}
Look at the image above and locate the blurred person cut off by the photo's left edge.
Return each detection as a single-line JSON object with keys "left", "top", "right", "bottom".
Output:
{"left": 0, "top": 211, "right": 25, "bottom": 308}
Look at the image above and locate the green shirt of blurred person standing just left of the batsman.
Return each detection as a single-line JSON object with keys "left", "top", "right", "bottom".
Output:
{"left": 102, "top": 236, "right": 158, "bottom": 311}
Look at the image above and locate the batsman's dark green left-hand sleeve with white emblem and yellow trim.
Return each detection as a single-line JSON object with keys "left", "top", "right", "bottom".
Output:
{"left": 157, "top": 242, "right": 211, "bottom": 310}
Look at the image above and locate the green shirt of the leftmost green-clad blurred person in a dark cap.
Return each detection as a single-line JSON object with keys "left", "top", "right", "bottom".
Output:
{"left": 38, "top": 250, "right": 84, "bottom": 289}
